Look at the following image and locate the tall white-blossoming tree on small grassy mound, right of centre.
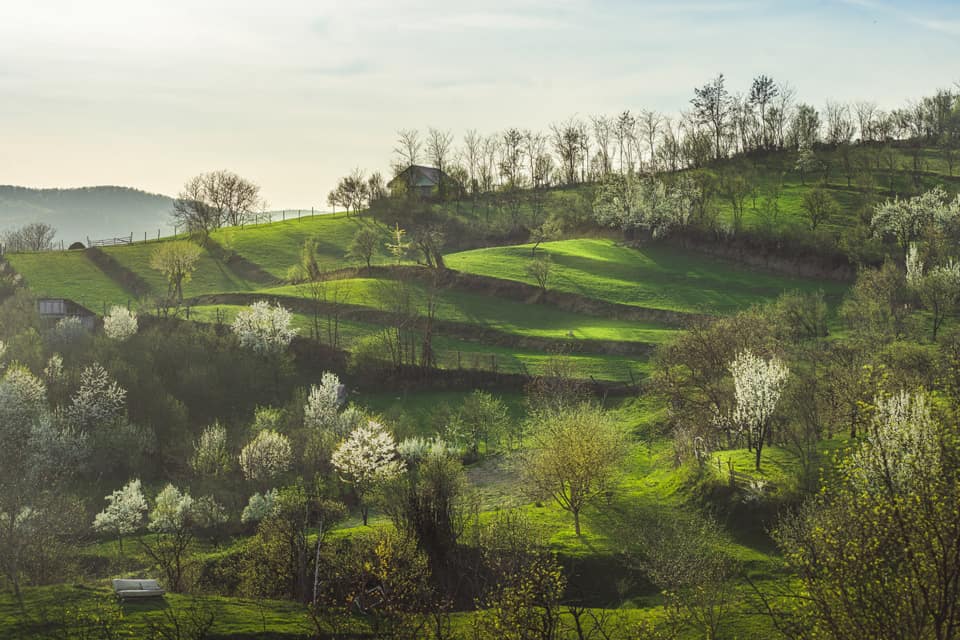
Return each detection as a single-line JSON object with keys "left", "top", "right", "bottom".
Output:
{"left": 729, "top": 349, "right": 790, "bottom": 471}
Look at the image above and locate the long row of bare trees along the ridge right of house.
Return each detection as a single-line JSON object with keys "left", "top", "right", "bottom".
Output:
{"left": 378, "top": 74, "right": 960, "bottom": 196}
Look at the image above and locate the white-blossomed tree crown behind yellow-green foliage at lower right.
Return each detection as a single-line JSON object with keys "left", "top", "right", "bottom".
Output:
{"left": 850, "top": 391, "right": 941, "bottom": 492}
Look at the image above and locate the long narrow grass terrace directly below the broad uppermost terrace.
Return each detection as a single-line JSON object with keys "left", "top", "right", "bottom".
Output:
{"left": 263, "top": 278, "right": 677, "bottom": 344}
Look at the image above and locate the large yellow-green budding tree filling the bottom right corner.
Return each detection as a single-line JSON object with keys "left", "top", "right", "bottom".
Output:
{"left": 766, "top": 392, "right": 960, "bottom": 639}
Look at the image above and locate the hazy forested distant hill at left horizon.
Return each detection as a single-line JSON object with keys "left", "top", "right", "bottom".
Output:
{"left": 0, "top": 185, "right": 173, "bottom": 244}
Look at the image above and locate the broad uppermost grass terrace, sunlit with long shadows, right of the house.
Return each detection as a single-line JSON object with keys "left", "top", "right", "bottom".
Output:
{"left": 446, "top": 239, "right": 846, "bottom": 314}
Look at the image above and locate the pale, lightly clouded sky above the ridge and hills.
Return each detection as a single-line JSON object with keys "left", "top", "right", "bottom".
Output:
{"left": 0, "top": 0, "right": 960, "bottom": 208}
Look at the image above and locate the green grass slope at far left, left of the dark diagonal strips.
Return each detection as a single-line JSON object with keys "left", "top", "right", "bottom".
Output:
{"left": 7, "top": 251, "right": 134, "bottom": 313}
